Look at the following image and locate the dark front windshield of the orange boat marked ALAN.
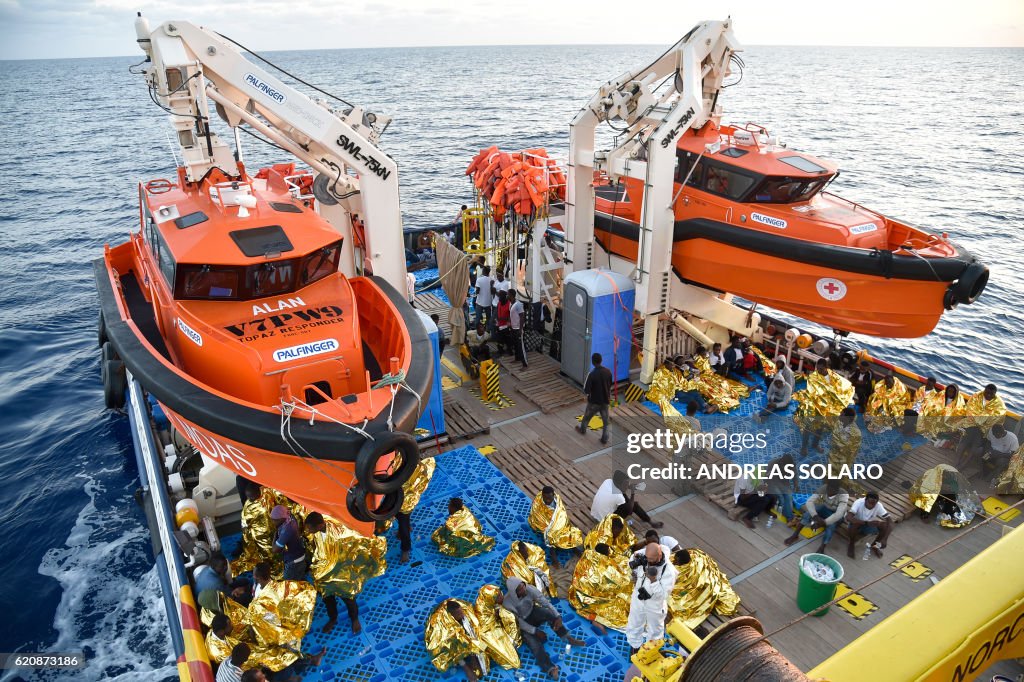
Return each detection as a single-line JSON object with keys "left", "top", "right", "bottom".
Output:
{"left": 175, "top": 241, "right": 341, "bottom": 301}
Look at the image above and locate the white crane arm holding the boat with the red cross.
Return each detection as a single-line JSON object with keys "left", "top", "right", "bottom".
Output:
{"left": 565, "top": 19, "right": 741, "bottom": 382}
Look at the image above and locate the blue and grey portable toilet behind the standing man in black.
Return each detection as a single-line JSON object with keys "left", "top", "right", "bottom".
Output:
{"left": 562, "top": 268, "right": 636, "bottom": 384}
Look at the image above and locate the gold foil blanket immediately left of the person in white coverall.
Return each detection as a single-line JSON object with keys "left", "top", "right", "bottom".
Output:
{"left": 568, "top": 549, "right": 633, "bottom": 630}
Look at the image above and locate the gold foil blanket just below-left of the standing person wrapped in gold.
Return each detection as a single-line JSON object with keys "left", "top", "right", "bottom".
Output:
{"left": 249, "top": 581, "right": 316, "bottom": 651}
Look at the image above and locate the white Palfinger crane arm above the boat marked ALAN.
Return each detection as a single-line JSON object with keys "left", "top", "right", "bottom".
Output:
{"left": 135, "top": 13, "right": 406, "bottom": 291}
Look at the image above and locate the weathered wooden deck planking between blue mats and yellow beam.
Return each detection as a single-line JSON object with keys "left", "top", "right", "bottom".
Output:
{"left": 434, "top": 354, "right": 1024, "bottom": 671}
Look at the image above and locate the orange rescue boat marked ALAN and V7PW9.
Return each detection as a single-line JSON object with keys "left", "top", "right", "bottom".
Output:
{"left": 94, "top": 163, "right": 433, "bottom": 534}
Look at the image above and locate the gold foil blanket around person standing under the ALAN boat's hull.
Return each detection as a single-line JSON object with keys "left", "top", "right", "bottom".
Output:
{"left": 309, "top": 517, "right": 387, "bottom": 599}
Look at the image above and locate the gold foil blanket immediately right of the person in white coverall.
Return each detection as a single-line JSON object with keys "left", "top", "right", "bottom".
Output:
{"left": 669, "top": 548, "right": 739, "bottom": 629}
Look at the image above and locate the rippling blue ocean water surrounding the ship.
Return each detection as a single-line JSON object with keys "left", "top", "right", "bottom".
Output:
{"left": 0, "top": 41, "right": 1024, "bottom": 681}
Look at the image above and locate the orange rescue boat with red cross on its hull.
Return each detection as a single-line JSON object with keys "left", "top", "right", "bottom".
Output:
{"left": 594, "top": 123, "right": 988, "bottom": 338}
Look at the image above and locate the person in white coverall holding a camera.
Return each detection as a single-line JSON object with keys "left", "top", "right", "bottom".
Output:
{"left": 626, "top": 543, "right": 679, "bottom": 652}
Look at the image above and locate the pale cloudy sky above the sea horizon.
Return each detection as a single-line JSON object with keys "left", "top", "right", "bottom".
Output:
{"left": 0, "top": 0, "right": 1024, "bottom": 59}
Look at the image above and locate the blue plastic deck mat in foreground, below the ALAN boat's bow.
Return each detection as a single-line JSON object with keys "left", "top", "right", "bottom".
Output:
{"left": 223, "top": 445, "right": 629, "bottom": 682}
